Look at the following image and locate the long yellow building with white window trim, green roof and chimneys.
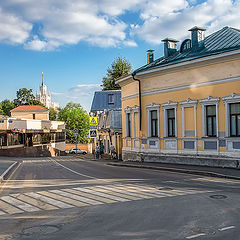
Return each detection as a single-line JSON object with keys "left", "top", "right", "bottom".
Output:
{"left": 117, "top": 27, "right": 240, "bottom": 167}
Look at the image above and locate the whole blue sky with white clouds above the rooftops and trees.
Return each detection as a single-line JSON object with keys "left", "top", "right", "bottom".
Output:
{"left": 0, "top": 0, "right": 240, "bottom": 110}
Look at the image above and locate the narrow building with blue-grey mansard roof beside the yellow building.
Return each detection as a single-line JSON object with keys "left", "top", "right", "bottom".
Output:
{"left": 90, "top": 90, "right": 122, "bottom": 158}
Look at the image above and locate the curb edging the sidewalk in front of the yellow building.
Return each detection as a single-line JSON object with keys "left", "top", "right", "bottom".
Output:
{"left": 107, "top": 163, "right": 240, "bottom": 181}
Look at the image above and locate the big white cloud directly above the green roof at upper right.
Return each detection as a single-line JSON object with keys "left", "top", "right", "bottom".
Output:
{"left": 131, "top": 0, "right": 240, "bottom": 44}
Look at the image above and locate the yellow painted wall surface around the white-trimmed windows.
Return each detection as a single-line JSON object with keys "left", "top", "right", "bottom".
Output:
{"left": 121, "top": 56, "right": 240, "bottom": 152}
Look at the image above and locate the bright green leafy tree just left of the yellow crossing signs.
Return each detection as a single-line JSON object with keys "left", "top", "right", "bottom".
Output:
{"left": 58, "top": 102, "right": 89, "bottom": 143}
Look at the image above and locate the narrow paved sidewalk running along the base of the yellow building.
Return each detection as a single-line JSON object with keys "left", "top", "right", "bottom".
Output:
{"left": 108, "top": 161, "right": 240, "bottom": 180}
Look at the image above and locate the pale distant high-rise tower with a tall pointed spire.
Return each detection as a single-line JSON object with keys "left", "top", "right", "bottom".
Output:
{"left": 36, "top": 73, "right": 59, "bottom": 110}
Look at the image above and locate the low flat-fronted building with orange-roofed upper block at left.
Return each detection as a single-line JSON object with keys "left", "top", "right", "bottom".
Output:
{"left": 0, "top": 106, "right": 66, "bottom": 157}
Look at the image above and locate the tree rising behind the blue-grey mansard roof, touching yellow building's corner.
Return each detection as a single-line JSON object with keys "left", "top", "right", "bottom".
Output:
{"left": 102, "top": 57, "right": 131, "bottom": 90}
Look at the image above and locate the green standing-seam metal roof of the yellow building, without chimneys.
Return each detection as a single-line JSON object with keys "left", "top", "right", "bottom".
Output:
{"left": 134, "top": 27, "right": 240, "bottom": 73}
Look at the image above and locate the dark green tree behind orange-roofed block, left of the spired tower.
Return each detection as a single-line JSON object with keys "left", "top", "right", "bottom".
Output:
{"left": 14, "top": 88, "right": 43, "bottom": 106}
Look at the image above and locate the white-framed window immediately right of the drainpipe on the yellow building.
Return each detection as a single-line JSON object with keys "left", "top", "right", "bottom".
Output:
{"left": 146, "top": 103, "right": 160, "bottom": 137}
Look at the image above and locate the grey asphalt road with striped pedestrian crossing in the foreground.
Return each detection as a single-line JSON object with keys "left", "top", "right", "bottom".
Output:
{"left": 0, "top": 156, "right": 240, "bottom": 240}
